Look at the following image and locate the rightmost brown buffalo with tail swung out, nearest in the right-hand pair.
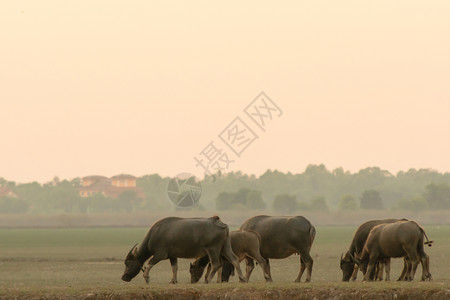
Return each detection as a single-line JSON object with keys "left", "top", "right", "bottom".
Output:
{"left": 359, "top": 221, "right": 432, "bottom": 281}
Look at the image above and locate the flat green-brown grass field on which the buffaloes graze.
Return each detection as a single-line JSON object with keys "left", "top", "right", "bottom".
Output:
{"left": 0, "top": 226, "right": 450, "bottom": 298}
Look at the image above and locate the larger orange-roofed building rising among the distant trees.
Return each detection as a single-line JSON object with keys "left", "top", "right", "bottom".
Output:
{"left": 80, "top": 174, "right": 145, "bottom": 198}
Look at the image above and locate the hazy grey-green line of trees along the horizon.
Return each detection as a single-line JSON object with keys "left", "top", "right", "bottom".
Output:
{"left": 0, "top": 164, "right": 450, "bottom": 213}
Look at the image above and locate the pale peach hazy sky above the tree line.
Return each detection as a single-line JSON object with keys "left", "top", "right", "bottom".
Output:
{"left": 0, "top": 0, "right": 450, "bottom": 182}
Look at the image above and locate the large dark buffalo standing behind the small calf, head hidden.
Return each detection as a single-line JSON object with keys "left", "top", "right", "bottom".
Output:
{"left": 237, "top": 215, "right": 316, "bottom": 282}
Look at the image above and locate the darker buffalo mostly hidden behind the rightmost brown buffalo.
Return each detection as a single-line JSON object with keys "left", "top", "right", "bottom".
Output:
{"left": 341, "top": 219, "right": 407, "bottom": 281}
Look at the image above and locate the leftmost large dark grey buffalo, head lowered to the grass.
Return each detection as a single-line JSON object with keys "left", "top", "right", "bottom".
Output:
{"left": 122, "top": 216, "right": 244, "bottom": 283}
